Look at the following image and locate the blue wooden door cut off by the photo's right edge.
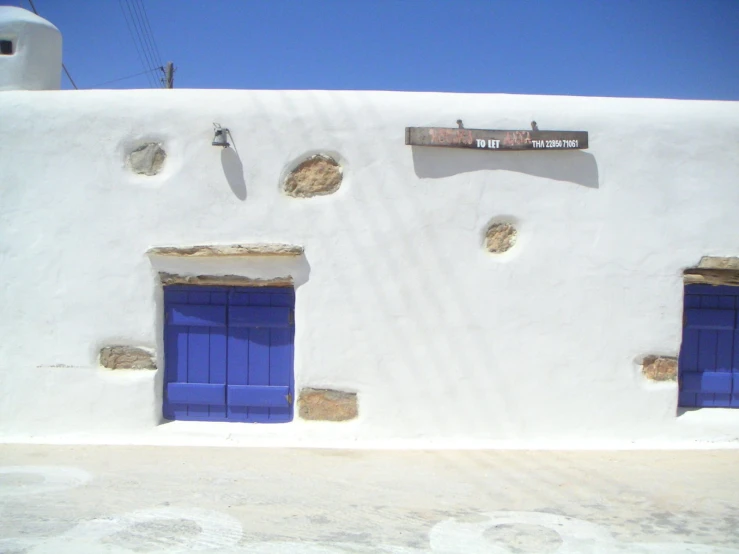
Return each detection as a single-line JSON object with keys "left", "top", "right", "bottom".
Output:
{"left": 678, "top": 285, "right": 739, "bottom": 408}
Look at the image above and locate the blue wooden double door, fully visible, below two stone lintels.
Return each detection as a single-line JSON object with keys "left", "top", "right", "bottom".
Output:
{"left": 163, "top": 285, "right": 295, "bottom": 423}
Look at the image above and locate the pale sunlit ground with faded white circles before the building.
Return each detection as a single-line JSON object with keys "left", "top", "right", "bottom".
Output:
{"left": 0, "top": 445, "right": 739, "bottom": 554}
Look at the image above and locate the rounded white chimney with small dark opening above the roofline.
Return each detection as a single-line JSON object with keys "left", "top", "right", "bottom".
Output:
{"left": 0, "top": 6, "right": 62, "bottom": 90}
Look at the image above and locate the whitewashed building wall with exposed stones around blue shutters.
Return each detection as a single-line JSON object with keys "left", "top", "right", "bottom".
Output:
{"left": 0, "top": 90, "right": 739, "bottom": 446}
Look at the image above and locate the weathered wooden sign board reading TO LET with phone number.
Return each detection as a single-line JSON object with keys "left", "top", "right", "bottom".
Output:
{"left": 405, "top": 127, "right": 588, "bottom": 151}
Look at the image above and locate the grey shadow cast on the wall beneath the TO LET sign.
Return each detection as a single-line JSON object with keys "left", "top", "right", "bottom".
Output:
{"left": 411, "top": 146, "right": 599, "bottom": 189}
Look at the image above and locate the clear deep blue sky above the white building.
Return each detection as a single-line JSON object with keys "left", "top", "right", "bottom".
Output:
{"left": 5, "top": 0, "right": 739, "bottom": 100}
